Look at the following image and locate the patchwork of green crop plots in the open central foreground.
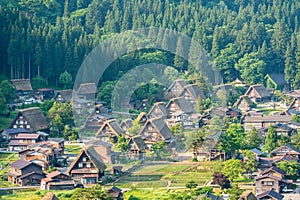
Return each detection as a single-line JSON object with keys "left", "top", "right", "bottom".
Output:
{"left": 111, "top": 161, "right": 221, "bottom": 188}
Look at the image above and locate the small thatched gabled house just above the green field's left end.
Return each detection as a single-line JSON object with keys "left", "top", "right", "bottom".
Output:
{"left": 127, "top": 136, "right": 147, "bottom": 160}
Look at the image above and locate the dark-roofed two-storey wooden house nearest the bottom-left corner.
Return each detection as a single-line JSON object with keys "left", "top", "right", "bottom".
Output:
{"left": 7, "top": 160, "right": 45, "bottom": 186}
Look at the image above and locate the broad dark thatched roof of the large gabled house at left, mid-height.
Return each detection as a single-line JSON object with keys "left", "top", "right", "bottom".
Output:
{"left": 10, "top": 107, "right": 49, "bottom": 131}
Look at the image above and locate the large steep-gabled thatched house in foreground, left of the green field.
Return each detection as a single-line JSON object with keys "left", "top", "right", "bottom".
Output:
{"left": 67, "top": 145, "right": 106, "bottom": 184}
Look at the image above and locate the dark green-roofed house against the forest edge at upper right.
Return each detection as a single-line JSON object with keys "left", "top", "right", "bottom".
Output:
{"left": 265, "top": 73, "right": 290, "bottom": 92}
